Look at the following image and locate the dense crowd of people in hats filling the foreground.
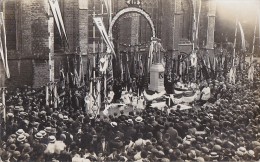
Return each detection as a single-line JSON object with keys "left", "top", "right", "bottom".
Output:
{"left": 0, "top": 76, "right": 260, "bottom": 162}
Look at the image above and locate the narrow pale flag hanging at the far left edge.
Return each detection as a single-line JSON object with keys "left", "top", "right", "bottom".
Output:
{"left": 0, "top": 12, "right": 10, "bottom": 78}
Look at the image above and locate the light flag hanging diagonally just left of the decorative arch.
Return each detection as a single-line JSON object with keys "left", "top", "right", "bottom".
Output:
{"left": 93, "top": 17, "right": 116, "bottom": 56}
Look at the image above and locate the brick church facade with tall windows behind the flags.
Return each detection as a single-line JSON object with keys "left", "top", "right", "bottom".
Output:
{"left": 0, "top": 0, "right": 216, "bottom": 87}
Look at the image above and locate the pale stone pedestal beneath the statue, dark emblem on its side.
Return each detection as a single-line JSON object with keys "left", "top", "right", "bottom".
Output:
{"left": 149, "top": 63, "right": 165, "bottom": 92}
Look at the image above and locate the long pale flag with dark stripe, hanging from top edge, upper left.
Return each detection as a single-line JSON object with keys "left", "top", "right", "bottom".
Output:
{"left": 49, "top": 0, "right": 68, "bottom": 44}
